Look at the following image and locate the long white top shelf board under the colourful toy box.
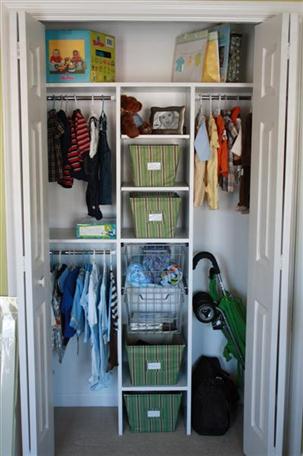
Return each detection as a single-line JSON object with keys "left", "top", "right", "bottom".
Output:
{"left": 46, "top": 82, "right": 253, "bottom": 90}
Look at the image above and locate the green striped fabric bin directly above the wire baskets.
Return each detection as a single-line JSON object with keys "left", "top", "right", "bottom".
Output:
{"left": 130, "top": 192, "right": 181, "bottom": 238}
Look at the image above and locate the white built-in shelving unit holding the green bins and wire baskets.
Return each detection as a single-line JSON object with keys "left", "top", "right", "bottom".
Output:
{"left": 47, "top": 82, "right": 252, "bottom": 434}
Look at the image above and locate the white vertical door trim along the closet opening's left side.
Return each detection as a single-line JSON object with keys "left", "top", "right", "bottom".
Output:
{"left": 1, "top": 7, "right": 30, "bottom": 455}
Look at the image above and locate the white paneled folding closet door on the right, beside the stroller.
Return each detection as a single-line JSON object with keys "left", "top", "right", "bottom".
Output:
{"left": 244, "top": 14, "right": 290, "bottom": 456}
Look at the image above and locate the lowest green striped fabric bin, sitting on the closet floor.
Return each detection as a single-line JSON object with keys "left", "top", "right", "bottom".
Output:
{"left": 124, "top": 393, "right": 182, "bottom": 432}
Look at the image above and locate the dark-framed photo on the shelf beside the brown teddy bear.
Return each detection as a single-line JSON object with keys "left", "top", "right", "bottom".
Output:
{"left": 150, "top": 106, "right": 185, "bottom": 135}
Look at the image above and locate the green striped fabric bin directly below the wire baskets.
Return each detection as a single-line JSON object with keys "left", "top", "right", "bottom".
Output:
{"left": 126, "top": 335, "right": 185, "bottom": 385}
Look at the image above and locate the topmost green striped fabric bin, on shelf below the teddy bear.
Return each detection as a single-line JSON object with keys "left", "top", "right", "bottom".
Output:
{"left": 129, "top": 144, "right": 180, "bottom": 187}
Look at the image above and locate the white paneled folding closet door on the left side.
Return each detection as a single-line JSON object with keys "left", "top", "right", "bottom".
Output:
{"left": 16, "top": 12, "right": 54, "bottom": 456}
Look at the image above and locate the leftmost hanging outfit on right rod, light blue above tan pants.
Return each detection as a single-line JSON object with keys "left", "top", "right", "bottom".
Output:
{"left": 194, "top": 109, "right": 211, "bottom": 207}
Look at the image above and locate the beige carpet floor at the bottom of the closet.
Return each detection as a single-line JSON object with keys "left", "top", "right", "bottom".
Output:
{"left": 55, "top": 407, "right": 243, "bottom": 456}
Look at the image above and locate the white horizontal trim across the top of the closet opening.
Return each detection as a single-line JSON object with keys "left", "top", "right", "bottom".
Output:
{"left": 3, "top": 0, "right": 303, "bottom": 23}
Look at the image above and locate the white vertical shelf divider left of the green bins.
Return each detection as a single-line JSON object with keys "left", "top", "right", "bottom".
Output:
{"left": 116, "top": 86, "right": 123, "bottom": 435}
